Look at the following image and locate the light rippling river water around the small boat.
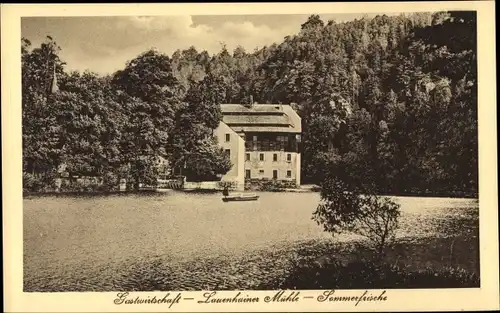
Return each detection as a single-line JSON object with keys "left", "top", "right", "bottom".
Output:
{"left": 23, "top": 191, "right": 477, "bottom": 291}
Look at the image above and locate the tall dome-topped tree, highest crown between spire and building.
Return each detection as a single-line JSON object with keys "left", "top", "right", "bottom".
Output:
{"left": 112, "top": 50, "right": 180, "bottom": 189}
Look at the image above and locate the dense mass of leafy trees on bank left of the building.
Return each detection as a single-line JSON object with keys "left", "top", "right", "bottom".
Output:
{"left": 21, "top": 43, "right": 232, "bottom": 189}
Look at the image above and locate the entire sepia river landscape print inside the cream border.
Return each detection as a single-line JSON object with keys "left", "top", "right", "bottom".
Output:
{"left": 2, "top": 1, "right": 498, "bottom": 309}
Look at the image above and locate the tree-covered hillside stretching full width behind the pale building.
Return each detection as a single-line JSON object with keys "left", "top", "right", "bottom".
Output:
{"left": 22, "top": 12, "right": 478, "bottom": 195}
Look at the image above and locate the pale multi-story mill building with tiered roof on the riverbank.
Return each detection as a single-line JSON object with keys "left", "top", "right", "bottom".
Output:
{"left": 216, "top": 104, "right": 301, "bottom": 189}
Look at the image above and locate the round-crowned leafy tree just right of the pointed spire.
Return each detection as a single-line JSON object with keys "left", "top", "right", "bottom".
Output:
{"left": 56, "top": 72, "right": 125, "bottom": 187}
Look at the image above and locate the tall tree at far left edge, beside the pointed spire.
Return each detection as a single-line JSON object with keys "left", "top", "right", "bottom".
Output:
{"left": 21, "top": 37, "right": 65, "bottom": 180}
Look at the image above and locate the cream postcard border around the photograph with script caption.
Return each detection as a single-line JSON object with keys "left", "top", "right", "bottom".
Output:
{"left": 1, "top": 1, "right": 499, "bottom": 312}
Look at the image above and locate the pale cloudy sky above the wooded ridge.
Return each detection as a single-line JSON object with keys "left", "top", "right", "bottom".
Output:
{"left": 21, "top": 13, "right": 395, "bottom": 74}
